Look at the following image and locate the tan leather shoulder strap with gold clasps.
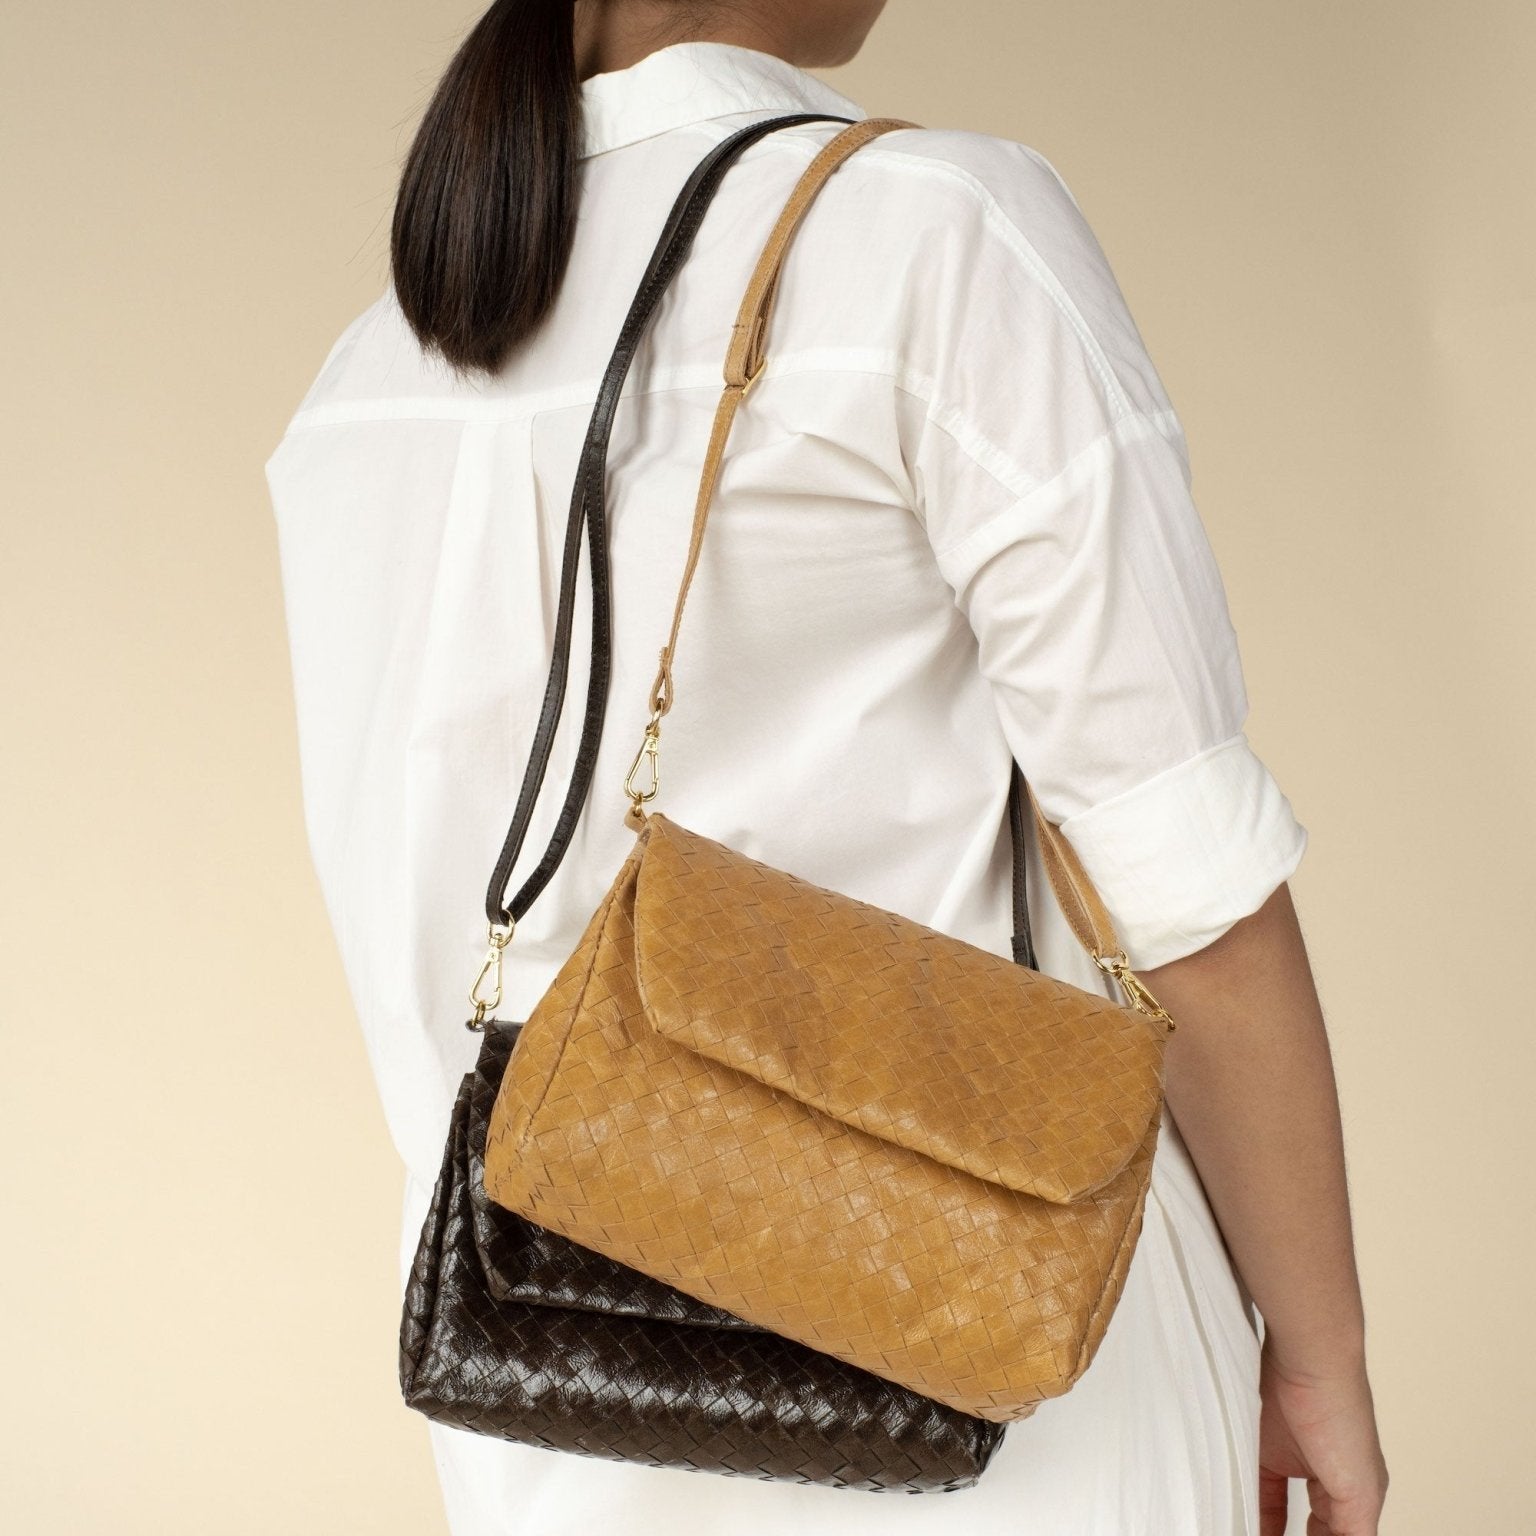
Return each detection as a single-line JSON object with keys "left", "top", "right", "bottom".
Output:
{"left": 625, "top": 117, "right": 1170, "bottom": 1023}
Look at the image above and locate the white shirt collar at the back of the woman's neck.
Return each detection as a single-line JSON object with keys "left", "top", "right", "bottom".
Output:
{"left": 581, "top": 43, "right": 868, "bottom": 157}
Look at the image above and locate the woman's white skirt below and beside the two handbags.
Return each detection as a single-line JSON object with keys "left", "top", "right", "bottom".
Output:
{"left": 401, "top": 1111, "right": 1260, "bottom": 1536}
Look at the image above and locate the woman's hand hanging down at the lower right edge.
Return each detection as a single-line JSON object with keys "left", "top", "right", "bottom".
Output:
{"left": 1258, "top": 1338, "right": 1387, "bottom": 1536}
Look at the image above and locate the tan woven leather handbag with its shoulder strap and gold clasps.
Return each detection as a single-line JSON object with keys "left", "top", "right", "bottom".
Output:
{"left": 472, "top": 118, "right": 1172, "bottom": 1422}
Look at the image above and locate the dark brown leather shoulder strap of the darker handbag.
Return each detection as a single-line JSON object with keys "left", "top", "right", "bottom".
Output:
{"left": 473, "top": 112, "right": 1035, "bottom": 968}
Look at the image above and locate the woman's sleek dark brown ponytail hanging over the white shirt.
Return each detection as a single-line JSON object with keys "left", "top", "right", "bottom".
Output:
{"left": 390, "top": 0, "right": 581, "bottom": 376}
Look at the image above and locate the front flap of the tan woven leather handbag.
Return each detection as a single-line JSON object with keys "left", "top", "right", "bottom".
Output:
{"left": 634, "top": 813, "right": 1164, "bottom": 1203}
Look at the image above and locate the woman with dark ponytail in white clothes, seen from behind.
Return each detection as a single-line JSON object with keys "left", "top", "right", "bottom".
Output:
{"left": 267, "top": 0, "right": 1387, "bottom": 1536}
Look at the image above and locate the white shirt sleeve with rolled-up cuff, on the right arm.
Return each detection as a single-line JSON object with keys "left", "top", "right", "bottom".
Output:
{"left": 911, "top": 138, "right": 1307, "bottom": 968}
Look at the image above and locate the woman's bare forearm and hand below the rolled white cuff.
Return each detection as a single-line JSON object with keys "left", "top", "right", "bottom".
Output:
{"left": 1140, "top": 883, "right": 1387, "bottom": 1536}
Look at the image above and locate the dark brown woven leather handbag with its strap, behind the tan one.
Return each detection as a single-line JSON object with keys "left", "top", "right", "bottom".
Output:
{"left": 399, "top": 114, "right": 1034, "bottom": 1493}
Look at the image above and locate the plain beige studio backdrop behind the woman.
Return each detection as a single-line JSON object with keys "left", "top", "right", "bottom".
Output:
{"left": 0, "top": 0, "right": 1536, "bottom": 1536}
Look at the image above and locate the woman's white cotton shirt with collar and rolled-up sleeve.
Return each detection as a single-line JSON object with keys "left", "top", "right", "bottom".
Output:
{"left": 266, "top": 43, "right": 1306, "bottom": 1536}
